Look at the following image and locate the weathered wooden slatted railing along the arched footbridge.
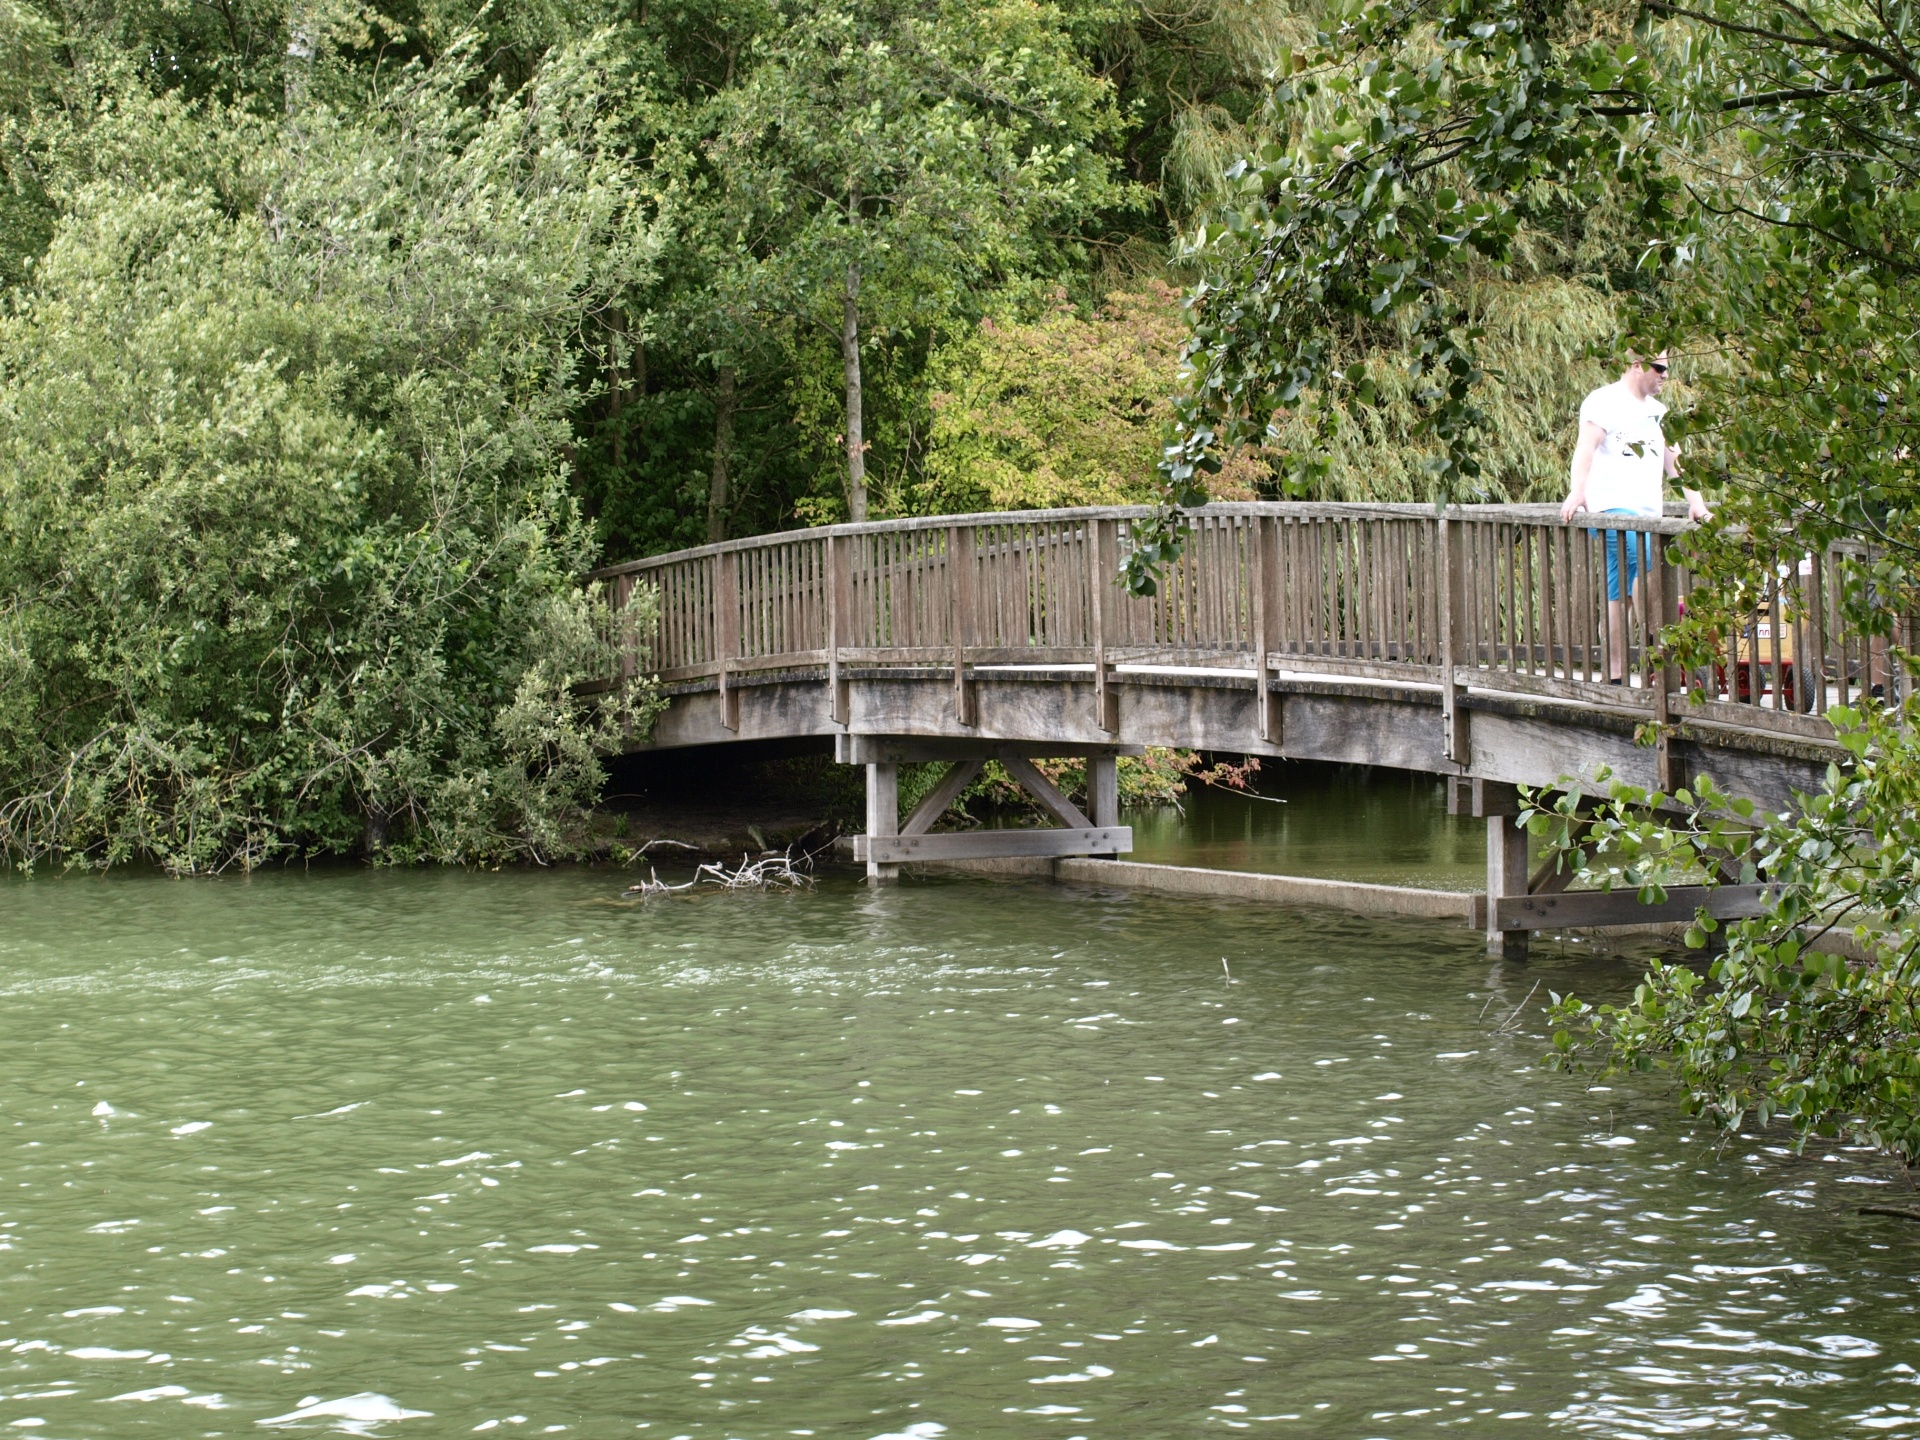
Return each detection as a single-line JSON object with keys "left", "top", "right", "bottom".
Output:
{"left": 597, "top": 503, "right": 1912, "bottom": 737}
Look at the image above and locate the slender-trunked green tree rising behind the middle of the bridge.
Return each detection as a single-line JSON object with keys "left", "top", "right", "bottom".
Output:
{"left": 714, "top": 0, "right": 1125, "bottom": 520}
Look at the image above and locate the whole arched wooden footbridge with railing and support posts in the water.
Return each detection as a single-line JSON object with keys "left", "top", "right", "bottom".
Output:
{"left": 599, "top": 503, "right": 1905, "bottom": 950}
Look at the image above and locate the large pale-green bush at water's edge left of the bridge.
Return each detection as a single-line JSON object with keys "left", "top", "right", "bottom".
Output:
{"left": 0, "top": 44, "right": 651, "bottom": 872}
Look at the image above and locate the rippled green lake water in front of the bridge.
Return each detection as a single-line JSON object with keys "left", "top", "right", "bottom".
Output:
{"left": 0, "top": 872, "right": 1920, "bottom": 1440}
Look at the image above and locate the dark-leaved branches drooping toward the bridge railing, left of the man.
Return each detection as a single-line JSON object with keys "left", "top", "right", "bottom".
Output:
{"left": 1136, "top": 0, "right": 1667, "bottom": 518}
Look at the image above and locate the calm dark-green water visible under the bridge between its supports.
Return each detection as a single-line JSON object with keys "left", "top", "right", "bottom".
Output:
{"left": 1125, "top": 760, "right": 1486, "bottom": 891}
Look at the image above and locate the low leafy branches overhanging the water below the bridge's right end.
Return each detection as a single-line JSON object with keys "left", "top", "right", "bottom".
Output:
{"left": 1528, "top": 701, "right": 1920, "bottom": 1165}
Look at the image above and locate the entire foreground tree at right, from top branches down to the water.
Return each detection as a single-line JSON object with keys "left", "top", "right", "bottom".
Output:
{"left": 1131, "top": 0, "right": 1920, "bottom": 1160}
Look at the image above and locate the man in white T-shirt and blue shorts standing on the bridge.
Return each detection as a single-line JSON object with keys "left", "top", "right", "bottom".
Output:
{"left": 1561, "top": 349, "right": 1707, "bottom": 685}
